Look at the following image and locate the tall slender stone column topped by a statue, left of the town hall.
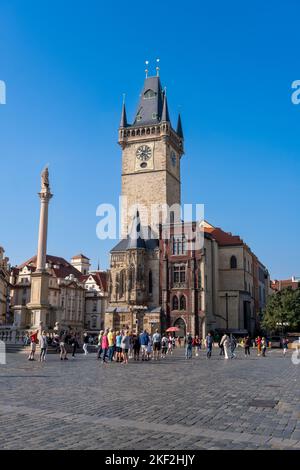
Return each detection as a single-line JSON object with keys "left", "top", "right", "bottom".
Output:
{"left": 27, "top": 168, "right": 53, "bottom": 329}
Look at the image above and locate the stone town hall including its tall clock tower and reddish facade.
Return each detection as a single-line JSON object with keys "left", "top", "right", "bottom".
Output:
{"left": 105, "top": 70, "right": 269, "bottom": 336}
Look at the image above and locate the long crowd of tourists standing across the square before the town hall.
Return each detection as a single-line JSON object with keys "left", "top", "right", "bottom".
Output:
{"left": 24, "top": 329, "right": 289, "bottom": 364}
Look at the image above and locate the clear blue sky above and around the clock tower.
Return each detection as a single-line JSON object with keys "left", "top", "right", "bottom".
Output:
{"left": 0, "top": 0, "right": 300, "bottom": 278}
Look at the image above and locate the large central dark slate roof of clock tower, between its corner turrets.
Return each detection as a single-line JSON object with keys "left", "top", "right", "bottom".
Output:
{"left": 134, "top": 77, "right": 164, "bottom": 125}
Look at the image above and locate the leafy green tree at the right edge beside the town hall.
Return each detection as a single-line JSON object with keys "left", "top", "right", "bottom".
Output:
{"left": 262, "top": 287, "right": 300, "bottom": 331}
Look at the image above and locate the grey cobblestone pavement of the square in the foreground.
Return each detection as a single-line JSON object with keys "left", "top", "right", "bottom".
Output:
{"left": 0, "top": 349, "right": 300, "bottom": 450}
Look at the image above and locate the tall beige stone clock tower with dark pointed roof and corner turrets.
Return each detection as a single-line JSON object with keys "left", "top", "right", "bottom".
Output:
{"left": 119, "top": 76, "right": 184, "bottom": 236}
